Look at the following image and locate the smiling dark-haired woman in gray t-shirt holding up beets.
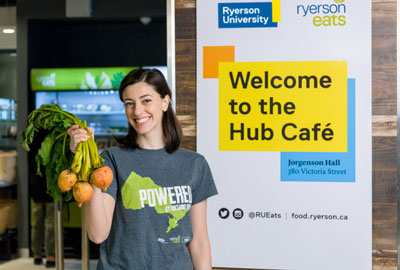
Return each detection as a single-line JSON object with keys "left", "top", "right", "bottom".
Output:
{"left": 68, "top": 69, "right": 217, "bottom": 270}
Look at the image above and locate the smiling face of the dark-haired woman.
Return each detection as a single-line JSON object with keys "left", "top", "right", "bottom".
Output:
{"left": 122, "top": 82, "right": 170, "bottom": 137}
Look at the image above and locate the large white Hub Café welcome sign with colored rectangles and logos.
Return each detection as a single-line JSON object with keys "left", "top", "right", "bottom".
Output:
{"left": 197, "top": 0, "right": 372, "bottom": 270}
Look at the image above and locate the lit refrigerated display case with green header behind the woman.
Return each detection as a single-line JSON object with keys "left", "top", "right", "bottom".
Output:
{"left": 31, "top": 67, "right": 136, "bottom": 150}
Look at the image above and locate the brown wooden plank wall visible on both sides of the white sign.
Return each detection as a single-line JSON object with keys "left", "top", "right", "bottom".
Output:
{"left": 175, "top": 0, "right": 397, "bottom": 270}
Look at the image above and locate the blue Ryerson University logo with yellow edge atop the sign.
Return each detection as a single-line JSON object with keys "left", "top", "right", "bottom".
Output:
{"left": 218, "top": 0, "right": 280, "bottom": 28}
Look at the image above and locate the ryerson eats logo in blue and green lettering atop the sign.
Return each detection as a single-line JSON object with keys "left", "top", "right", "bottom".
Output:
{"left": 296, "top": 0, "right": 347, "bottom": 27}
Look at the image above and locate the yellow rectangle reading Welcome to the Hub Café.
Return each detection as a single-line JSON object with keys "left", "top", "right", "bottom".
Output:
{"left": 219, "top": 61, "right": 347, "bottom": 152}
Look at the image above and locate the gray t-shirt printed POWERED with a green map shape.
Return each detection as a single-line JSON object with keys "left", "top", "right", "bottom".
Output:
{"left": 97, "top": 147, "right": 217, "bottom": 270}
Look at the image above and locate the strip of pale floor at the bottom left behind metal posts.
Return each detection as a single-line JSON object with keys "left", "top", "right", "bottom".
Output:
{"left": 0, "top": 258, "right": 97, "bottom": 270}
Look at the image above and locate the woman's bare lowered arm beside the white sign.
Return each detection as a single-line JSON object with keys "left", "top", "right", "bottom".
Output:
{"left": 189, "top": 200, "right": 211, "bottom": 270}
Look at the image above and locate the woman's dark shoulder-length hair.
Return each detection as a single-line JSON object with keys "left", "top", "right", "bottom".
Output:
{"left": 115, "top": 69, "right": 182, "bottom": 153}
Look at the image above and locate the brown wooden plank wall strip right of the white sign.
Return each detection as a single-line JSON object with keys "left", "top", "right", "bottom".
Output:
{"left": 372, "top": 0, "right": 398, "bottom": 270}
